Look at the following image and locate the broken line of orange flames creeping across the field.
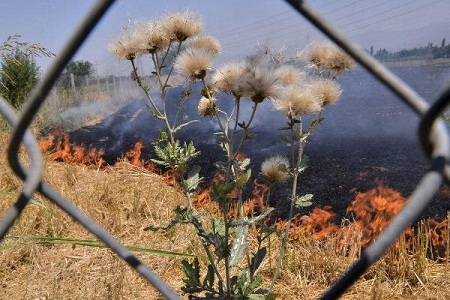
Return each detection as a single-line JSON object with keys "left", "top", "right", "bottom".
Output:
{"left": 39, "top": 130, "right": 450, "bottom": 258}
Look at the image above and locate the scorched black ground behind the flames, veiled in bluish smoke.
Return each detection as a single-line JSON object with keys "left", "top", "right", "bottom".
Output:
{"left": 65, "top": 66, "right": 450, "bottom": 217}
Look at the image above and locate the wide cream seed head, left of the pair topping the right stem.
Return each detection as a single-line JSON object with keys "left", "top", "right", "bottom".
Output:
{"left": 272, "top": 86, "right": 322, "bottom": 117}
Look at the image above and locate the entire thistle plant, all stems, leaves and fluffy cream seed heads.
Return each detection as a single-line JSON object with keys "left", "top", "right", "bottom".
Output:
{"left": 109, "top": 11, "right": 351, "bottom": 299}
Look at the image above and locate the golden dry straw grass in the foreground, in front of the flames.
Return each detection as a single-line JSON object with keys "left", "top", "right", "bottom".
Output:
{"left": 0, "top": 134, "right": 450, "bottom": 299}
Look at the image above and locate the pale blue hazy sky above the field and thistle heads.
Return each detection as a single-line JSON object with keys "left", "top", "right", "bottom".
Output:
{"left": 0, "top": 0, "right": 450, "bottom": 75}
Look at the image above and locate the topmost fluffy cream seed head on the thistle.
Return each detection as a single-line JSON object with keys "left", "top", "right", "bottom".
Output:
{"left": 161, "top": 10, "right": 203, "bottom": 42}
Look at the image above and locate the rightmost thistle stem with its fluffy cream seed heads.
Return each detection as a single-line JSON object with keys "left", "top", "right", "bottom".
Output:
{"left": 268, "top": 44, "right": 352, "bottom": 291}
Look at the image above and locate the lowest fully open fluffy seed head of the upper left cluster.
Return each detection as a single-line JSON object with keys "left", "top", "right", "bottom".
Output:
{"left": 174, "top": 48, "right": 213, "bottom": 80}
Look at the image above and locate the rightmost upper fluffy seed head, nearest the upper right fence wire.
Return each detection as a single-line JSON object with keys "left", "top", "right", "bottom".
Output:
{"left": 308, "top": 44, "right": 353, "bottom": 74}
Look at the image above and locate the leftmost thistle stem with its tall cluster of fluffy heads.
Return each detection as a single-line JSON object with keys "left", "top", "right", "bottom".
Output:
{"left": 108, "top": 10, "right": 214, "bottom": 208}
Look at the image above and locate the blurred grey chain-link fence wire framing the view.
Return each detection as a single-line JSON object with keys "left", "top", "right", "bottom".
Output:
{"left": 0, "top": 0, "right": 450, "bottom": 299}
